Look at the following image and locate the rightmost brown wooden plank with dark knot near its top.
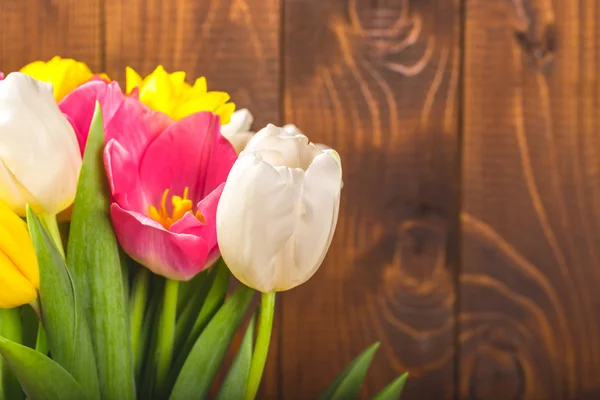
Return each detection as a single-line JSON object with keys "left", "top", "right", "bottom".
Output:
{"left": 459, "top": 0, "right": 600, "bottom": 400}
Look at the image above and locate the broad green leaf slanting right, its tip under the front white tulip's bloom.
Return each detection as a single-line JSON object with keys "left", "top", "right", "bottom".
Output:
{"left": 170, "top": 286, "right": 254, "bottom": 400}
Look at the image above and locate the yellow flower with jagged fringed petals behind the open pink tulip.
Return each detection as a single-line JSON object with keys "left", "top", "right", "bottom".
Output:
{"left": 126, "top": 65, "right": 235, "bottom": 125}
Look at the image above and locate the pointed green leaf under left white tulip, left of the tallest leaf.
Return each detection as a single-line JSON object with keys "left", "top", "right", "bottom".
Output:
{"left": 27, "top": 207, "right": 100, "bottom": 399}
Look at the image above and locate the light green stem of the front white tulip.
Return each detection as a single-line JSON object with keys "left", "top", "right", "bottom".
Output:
{"left": 246, "top": 292, "right": 275, "bottom": 400}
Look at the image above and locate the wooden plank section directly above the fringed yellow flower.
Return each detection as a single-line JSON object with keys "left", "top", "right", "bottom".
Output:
{"left": 105, "top": 0, "right": 280, "bottom": 127}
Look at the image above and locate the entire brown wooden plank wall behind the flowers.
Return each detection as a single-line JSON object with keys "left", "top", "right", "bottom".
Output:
{"left": 0, "top": 0, "right": 600, "bottom": 399}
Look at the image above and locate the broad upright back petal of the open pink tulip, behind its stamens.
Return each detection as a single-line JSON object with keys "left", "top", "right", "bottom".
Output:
{"left": 140, "top": 112, "right": 237, "bottom": 204}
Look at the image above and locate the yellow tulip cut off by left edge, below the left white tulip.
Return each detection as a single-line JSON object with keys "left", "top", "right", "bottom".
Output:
{"left": 0, "top": 201, "right": 40, "bottom": 308}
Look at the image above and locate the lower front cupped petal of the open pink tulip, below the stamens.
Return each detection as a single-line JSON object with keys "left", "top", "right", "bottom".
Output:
{"left": 110, "top": 203, "right": 213, "bottom": 280}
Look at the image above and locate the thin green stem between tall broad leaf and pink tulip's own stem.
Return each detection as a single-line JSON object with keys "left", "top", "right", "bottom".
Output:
{"left": 131, "top": 267, "right": 150, "bottom": 371}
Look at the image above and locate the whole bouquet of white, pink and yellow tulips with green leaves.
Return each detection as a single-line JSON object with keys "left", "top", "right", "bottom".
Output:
{"left": 0, "top": 57, "right": 406, "bottom": 400}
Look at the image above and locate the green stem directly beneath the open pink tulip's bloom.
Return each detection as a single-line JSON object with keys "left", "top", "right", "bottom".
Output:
{"left": 156, "top": 279, "right": 179, "bottom": 393}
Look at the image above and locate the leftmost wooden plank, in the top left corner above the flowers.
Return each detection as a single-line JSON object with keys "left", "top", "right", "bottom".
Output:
{"left": 0, "top": 0, "right": 103, "bottom": 72}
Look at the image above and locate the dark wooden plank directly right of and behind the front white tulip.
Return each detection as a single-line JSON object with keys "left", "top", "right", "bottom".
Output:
{"left": 280, "top": 0, "right": 460, "bottom": 399}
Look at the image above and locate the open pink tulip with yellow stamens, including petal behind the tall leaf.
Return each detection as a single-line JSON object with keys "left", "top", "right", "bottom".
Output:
{"left": 60, "top": 81, "right": 237, "bottom": 280}
